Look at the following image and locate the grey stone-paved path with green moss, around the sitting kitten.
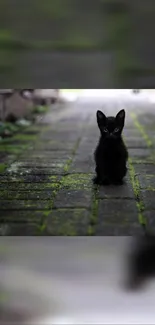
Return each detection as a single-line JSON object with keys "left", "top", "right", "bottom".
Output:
{"left": 0, "top": 97, "right": 155, "bottom": 236}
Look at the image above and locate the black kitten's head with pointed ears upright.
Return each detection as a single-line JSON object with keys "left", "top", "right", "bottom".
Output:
{"left": 96, "top": 109, "right": 125, "bottom": 139}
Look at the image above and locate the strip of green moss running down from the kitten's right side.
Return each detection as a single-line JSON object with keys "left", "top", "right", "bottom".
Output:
{"left": 128, "top": 158, "right": 146, "bottom": 225}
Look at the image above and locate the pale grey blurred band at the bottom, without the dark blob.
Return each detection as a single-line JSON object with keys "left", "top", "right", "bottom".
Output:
{"left": 0, "top": 237, "right": 155, "bottom": 325}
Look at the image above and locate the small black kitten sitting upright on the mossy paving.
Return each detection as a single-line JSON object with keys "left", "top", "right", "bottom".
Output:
{"left": 94, "top": 110, "right": 128, "bottom": 185}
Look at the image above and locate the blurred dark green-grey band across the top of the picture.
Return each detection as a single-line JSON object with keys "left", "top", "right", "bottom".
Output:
{"left": 0, "top": 0, "right": 155, "bottom": 88}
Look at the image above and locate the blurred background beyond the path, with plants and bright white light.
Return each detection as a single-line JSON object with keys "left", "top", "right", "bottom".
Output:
{"left": 0, "top": 88, "right": 155, "bottom": 139}
